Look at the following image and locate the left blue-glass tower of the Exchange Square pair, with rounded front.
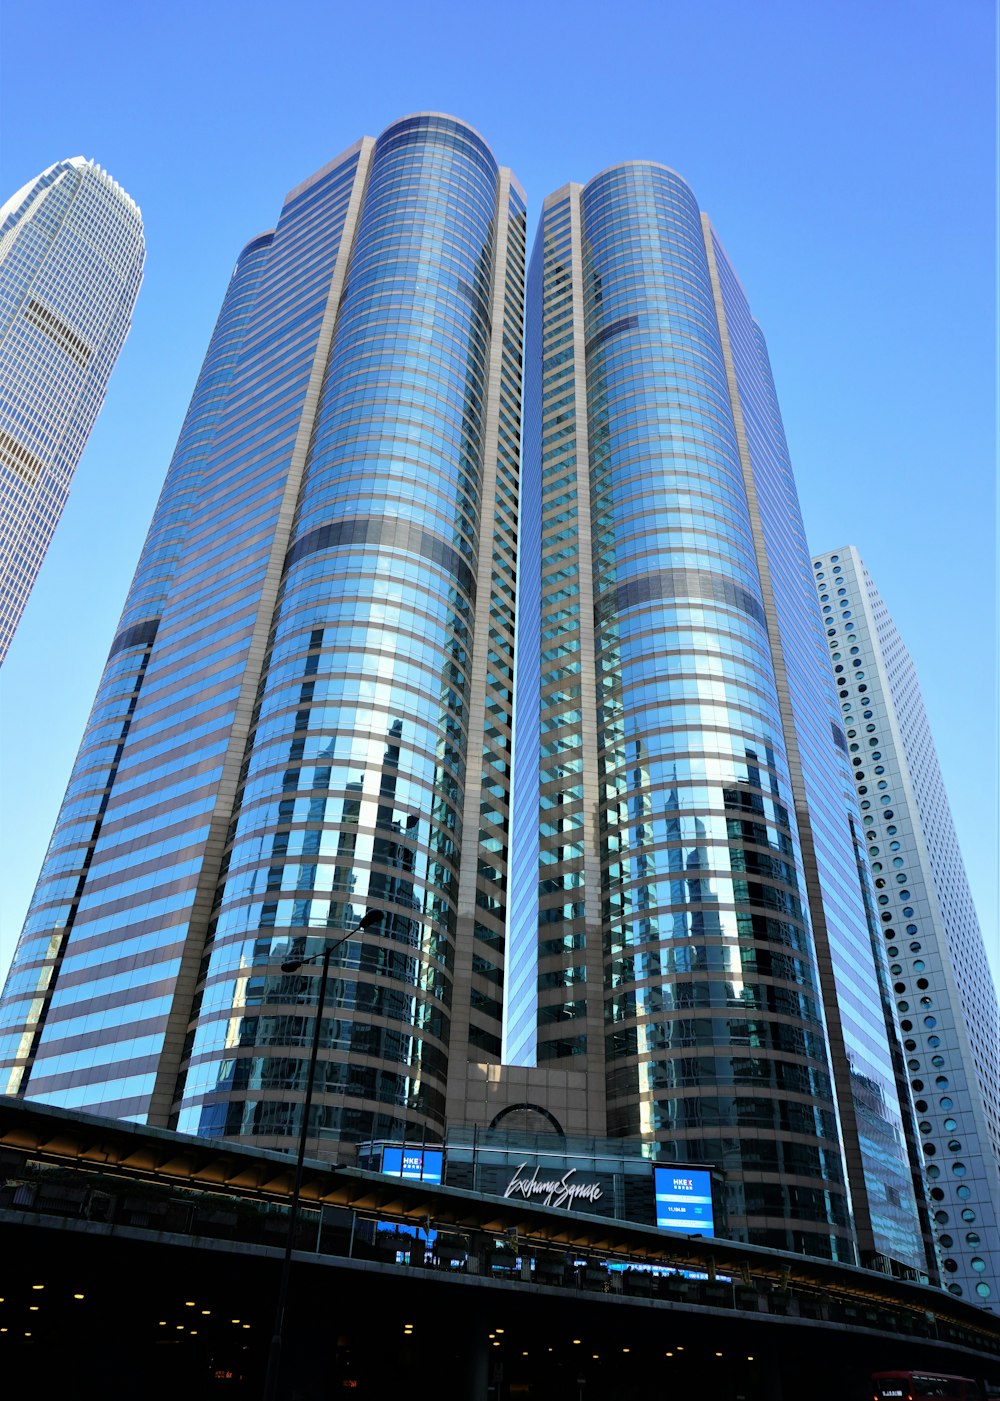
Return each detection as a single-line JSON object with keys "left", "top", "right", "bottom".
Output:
{"left": 1, "top": 113, "right": 524, "bottom": 1146}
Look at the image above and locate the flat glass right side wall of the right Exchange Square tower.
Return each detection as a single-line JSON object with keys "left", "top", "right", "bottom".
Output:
{"left": 711, "top": 234, "right": 926, "bottom": 1269}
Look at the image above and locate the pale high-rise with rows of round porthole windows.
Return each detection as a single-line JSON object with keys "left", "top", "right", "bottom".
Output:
{"left": 814, "top": 545, "right": 1000, "bottom": 1307}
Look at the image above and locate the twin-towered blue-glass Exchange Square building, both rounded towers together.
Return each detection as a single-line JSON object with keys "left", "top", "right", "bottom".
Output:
{"left": 0, "top": 126, "right": 952, "bottom": 1274}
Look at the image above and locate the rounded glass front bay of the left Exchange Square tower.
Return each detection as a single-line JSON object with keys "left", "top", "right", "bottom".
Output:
{"left": 179, "top": 118, "right": 524, "bottom": 1140}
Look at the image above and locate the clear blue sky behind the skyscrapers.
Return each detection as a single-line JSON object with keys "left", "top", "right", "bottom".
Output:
{"left": 0, "top": 0, "right": 1000, "bottom": 976}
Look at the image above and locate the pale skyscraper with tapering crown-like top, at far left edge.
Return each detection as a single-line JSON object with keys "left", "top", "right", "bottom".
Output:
{"left": 0, "top": 156, "right": 146, "bottom": 663}
